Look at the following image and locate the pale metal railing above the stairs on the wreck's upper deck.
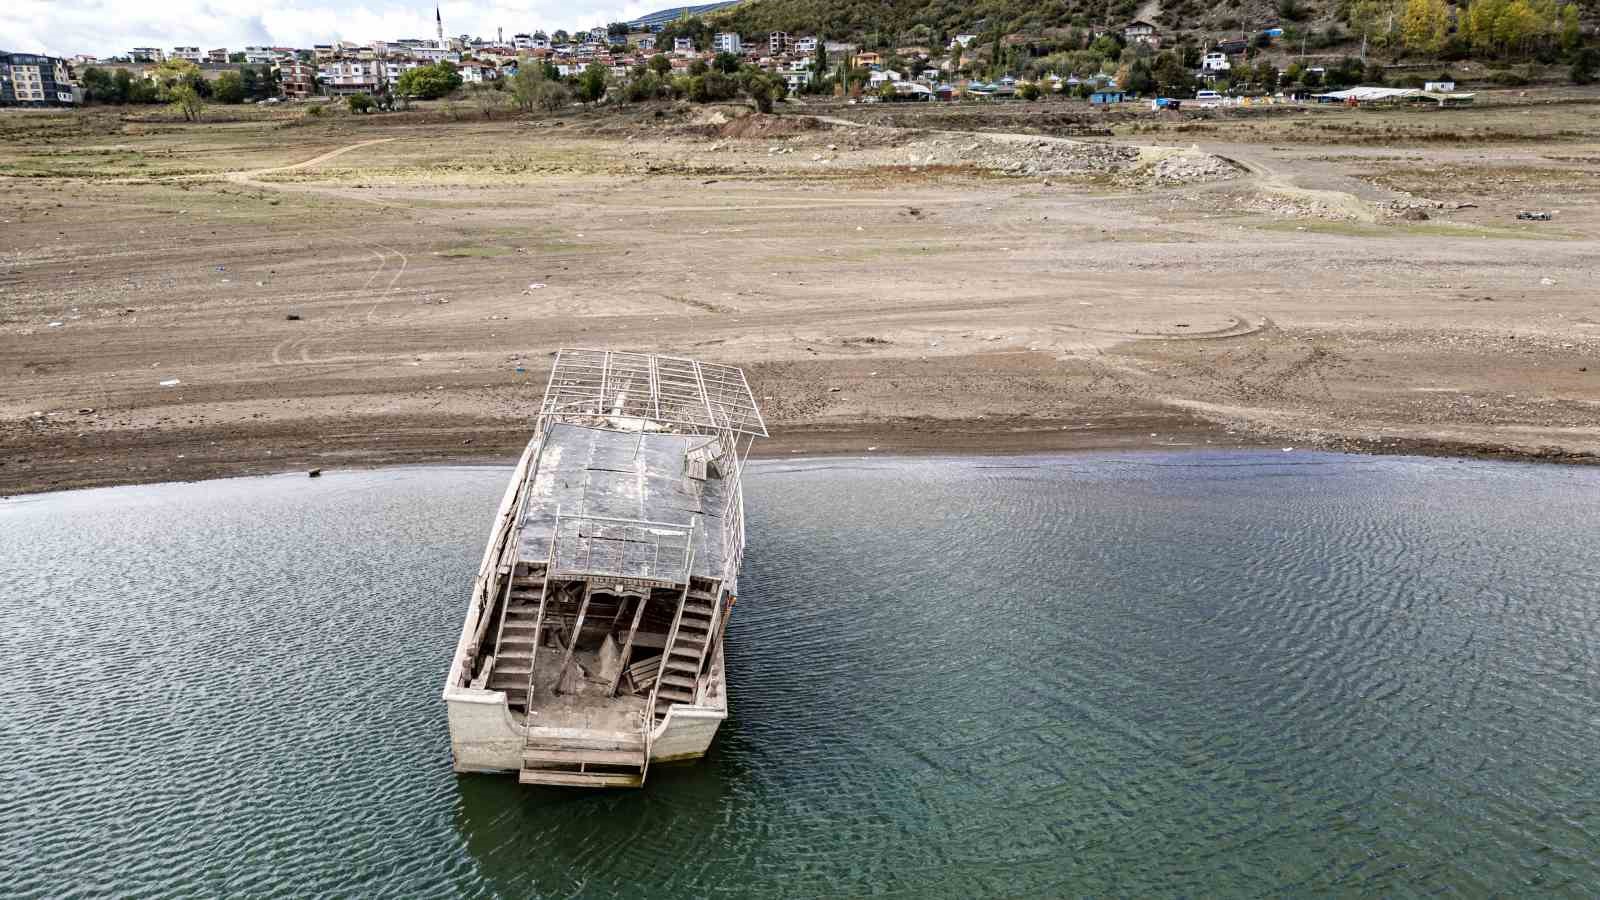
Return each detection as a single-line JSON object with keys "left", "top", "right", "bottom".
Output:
{"left": 550, "top": 516, "right": 694, "bottom": 585}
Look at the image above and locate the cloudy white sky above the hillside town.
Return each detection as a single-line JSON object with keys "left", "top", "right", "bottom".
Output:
{"left": 0, "top": 0, "right": 659, "bottom": 56}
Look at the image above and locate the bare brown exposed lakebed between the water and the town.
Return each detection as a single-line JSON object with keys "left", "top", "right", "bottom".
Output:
{"left": 0, "top": 94, "right": 1600, "bottom": 495}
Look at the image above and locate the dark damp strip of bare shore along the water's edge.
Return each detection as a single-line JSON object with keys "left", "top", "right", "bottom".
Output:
{"left": 0, "top": 412, "right": 1600, "bottom": 500}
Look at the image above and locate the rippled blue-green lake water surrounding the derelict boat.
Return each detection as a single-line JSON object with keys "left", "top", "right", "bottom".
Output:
{"left": 0, "top": 452, "right": 1600, "bottom": 897}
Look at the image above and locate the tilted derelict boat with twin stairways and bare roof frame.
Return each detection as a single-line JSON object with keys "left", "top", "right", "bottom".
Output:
{"left": 445, "top": 349, "right": 766, "bottom": 786}
